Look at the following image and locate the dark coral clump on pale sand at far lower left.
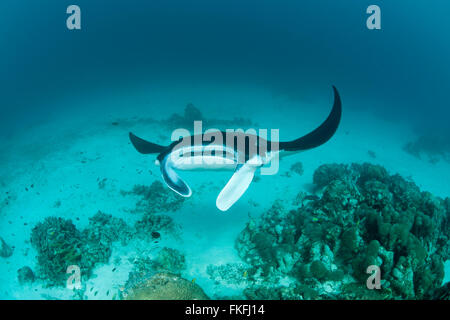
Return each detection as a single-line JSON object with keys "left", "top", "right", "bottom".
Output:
{"left": 31, "top": 212, "right": 130, "bottom": 285}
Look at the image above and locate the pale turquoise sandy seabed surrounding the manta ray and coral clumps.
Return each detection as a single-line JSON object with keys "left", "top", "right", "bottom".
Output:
{"left": 0, "top": 84, "right": 450, "bottom": 299}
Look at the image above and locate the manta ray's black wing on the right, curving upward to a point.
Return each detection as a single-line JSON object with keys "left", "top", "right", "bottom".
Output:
{"left": 279, "top": 86, "right": 342, "bottom": 151}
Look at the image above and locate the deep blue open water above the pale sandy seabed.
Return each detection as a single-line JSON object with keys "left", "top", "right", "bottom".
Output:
{"left": 0, "top": 0, "right": 450, "bottom": 133}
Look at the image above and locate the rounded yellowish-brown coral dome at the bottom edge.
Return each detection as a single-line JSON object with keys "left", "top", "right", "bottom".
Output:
{"left": 122, "top": 272, "right": 208, "bottom": 300}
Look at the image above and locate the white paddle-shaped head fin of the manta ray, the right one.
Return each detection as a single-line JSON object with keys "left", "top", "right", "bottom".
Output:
{"left": 216, "top": 162, "right": 258, "bottom": 211}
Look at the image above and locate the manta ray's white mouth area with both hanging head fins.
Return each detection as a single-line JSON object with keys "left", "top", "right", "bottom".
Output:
{"left": 161, "top": 146, "right": 262, "bottom": 211}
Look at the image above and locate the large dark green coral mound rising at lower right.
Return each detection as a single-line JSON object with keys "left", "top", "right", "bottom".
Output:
{"left": 235, "top": 163, "right": 450, "bottom": 299}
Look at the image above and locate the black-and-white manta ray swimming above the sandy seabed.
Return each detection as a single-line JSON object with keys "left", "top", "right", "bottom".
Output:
{"left": 129, "top": 86, "right": 342, "bottom": 211}
